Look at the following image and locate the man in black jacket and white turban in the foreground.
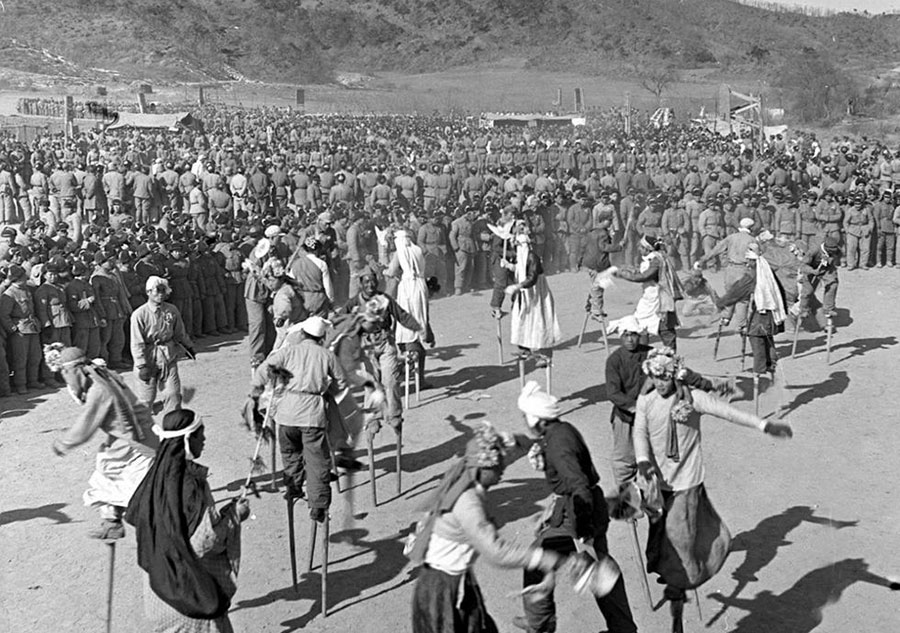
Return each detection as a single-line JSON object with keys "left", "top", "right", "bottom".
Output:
{"left": 513, "top": 381, "right": 637, "bottom": 633}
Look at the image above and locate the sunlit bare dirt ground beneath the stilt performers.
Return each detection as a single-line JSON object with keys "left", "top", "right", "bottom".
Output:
{"left": 0, "top": 269, "right": 900, "bottom": 633}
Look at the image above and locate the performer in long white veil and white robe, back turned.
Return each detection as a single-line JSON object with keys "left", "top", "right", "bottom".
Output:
{"left": 385, "top": 229, "right": 434, "bottom": 386}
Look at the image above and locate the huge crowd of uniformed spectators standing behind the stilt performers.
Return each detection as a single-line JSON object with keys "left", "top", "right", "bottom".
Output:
{"left": 0, "top": 106, "right": 900, "bottom": 396}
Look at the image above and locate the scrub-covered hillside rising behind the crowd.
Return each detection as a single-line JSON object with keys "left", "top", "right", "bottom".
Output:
{"left": 0, "top": 0, "right": 900, "bottom": 83}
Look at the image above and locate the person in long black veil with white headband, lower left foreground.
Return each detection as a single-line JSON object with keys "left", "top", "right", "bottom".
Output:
{"left": 125, "top": 409, "right": 250, "bottom": 633}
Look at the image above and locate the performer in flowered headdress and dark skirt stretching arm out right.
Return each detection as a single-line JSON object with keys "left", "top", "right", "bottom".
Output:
{"left": 634, "top": 350, "right": 793, "bottom": 633}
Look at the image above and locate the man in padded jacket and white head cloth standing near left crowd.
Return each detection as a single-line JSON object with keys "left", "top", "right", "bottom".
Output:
{"left": 131, "top": 275, "right": 196, "bottom": 412}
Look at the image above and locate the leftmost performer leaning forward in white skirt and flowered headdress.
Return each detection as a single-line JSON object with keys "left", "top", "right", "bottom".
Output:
{"left": 44, "top": 343, "right": 158, "bottom": 539}
